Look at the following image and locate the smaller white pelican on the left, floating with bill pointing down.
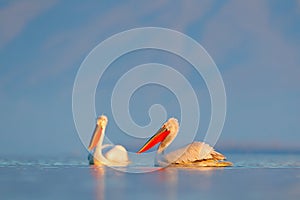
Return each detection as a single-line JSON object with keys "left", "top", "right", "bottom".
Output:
{"left": 88, "top": 115, "right": 129, "bottom": 166}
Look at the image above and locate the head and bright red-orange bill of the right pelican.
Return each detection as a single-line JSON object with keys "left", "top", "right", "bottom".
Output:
{"left": 137, "top": 118, "right": 179, "bottom": 153}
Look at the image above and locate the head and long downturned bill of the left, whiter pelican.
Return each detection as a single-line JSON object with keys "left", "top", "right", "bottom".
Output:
{"left": 88, "top": 115, "right": 108, "bottom": 151}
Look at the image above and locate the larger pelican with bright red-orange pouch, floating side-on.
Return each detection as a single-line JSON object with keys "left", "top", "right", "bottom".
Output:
{"left": 137, "top": 118, "right": 232, "bottom": 167}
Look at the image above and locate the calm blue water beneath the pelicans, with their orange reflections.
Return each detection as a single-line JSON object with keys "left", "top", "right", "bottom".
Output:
{"left": 0, "top": 154, "right": 300, "bottom": 200}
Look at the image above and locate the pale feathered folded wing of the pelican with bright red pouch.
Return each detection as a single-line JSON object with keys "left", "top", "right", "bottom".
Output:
{"left": 164, "top": 142, "right": 226, "bottom": 164}
